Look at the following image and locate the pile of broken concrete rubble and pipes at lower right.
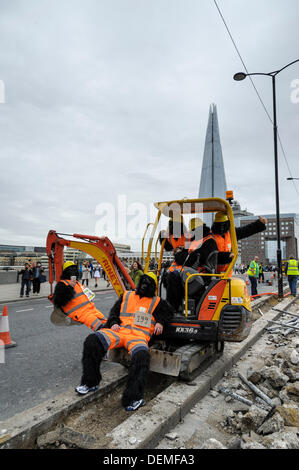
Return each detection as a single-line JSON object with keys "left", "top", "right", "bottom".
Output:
{"left": 218, "top": 318, "right": 299, "bottom": 449}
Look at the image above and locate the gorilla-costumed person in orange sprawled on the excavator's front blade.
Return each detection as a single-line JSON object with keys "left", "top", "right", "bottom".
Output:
{"left": 76, "top": 272, "right": 172, "bottom": 411}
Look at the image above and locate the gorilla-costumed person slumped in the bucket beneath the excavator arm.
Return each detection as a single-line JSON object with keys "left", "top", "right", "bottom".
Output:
{"left": 51, "top": 261, "right": 106, "bottom": 331}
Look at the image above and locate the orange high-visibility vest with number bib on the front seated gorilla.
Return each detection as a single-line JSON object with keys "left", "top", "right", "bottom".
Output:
{"left": 119, "top": 291, "right": 160, "bottom": 337}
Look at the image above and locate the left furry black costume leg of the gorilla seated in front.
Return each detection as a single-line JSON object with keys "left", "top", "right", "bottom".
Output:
{"left": 81, "top": 333, "right": 106, "bottom": 387}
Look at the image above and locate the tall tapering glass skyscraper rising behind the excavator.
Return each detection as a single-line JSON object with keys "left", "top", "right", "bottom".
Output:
{"left": 198, "top": 104, "right": 226, "bottom": 226}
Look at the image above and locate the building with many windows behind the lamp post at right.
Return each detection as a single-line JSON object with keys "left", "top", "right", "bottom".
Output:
{"left": 238, "top": 213, "right": 299, "bottom": 265}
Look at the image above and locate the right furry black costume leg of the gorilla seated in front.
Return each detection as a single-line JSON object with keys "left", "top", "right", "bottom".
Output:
{"left": 122, "top": 349, "right": 150, "bottom": 407}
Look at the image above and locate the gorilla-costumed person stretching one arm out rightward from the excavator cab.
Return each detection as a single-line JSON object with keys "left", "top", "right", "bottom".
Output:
{"left": 211, "top": 212, "right": 267, "bottom": 273}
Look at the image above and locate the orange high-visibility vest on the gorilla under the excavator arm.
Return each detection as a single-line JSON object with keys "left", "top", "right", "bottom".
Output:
{"left": 60, "top": 279, "right": 107, "bottom": 331}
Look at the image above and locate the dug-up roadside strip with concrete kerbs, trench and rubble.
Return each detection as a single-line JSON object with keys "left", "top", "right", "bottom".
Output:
{"left": 0, "top": 290, "right": 299, "bottom": 450}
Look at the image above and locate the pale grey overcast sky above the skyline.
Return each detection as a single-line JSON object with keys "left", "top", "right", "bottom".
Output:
{"left": 0, "top": 0, "right": 299, "bottom": 249}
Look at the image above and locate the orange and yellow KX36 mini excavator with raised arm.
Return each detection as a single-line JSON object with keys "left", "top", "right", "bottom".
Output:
{"left": 47, "top": 196, "right": 252, "bottom": 381}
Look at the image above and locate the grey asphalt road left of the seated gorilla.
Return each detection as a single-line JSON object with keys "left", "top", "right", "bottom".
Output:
{"left": 0, "top": 291, "right": 117, "bottom": 421}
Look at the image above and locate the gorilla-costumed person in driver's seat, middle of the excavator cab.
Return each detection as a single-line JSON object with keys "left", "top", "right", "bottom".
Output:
{"left": 165, "top": 217, "right": 218, "bottom": 311}
